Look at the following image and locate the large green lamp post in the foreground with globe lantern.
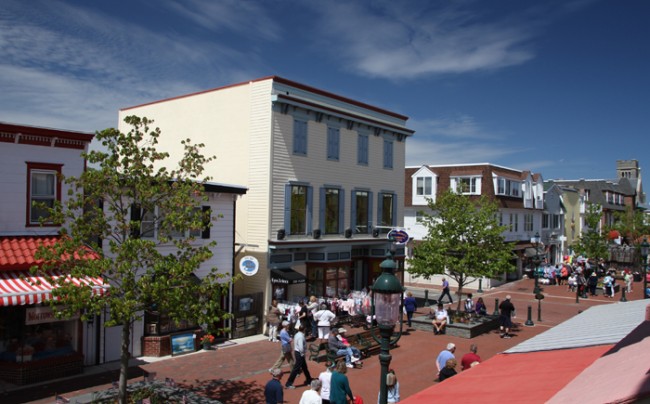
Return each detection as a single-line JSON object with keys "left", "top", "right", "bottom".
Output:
{"left": 371, "top": 250, "right": 404, "bottom": 404}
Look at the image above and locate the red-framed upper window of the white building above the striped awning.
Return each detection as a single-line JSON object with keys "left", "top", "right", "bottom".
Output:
{"left": 27, "top": 163, "right": 63, "bottom": 226}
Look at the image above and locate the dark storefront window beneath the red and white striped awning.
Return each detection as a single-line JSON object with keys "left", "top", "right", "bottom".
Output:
{"left": 0, "top": 306, "right": 79, "bottom": 362}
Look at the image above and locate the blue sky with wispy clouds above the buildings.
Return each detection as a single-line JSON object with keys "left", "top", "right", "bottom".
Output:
{"left": 0, "top": 0, "right": 650, "bottom": 179}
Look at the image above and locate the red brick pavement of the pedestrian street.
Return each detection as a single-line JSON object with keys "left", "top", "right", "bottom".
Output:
{"left": 15, "top": 279, "right": 641, "bottom": 404}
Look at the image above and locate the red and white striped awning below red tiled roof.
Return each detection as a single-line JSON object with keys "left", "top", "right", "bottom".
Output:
{"left": 0, "top": 271, "right": 109, "bottom": 306}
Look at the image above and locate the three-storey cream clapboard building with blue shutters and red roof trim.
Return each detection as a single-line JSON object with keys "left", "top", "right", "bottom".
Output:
{"left": 120, "top": 76, "right": 413, "bottom": 337}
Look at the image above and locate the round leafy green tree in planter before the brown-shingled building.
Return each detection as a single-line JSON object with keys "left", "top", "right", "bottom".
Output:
{"left": 408, "top": 190, "right": 514, "bottom": 310}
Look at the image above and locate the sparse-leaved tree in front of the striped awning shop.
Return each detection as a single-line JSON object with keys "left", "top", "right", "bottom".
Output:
{"left": 33, "top": 116, "right": 233, "bottom": 403}
